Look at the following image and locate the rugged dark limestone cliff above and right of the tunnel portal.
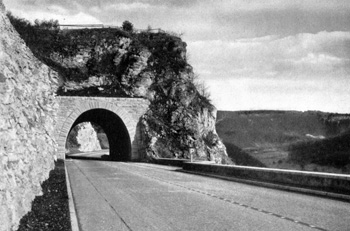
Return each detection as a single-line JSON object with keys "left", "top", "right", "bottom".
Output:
{"left": 8, "top": 17, "right": 229, "bottom": 163}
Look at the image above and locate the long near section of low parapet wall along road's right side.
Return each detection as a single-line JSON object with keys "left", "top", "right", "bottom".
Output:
{"left": 182, "top": 162, "right": 350, "bottom": 199}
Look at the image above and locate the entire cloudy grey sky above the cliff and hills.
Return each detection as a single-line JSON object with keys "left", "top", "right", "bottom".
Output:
{"left": 3, "top": 0, "right": 350, "bottom": 113}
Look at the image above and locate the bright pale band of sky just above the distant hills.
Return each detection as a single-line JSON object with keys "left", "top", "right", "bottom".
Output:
{"left": 206, "top": 78, "right": 350, "bottom": 113}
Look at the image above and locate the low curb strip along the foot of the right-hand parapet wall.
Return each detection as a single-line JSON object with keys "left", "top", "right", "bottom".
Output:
{"left": 177, "top": 169, "right": 350, "bottom": 202}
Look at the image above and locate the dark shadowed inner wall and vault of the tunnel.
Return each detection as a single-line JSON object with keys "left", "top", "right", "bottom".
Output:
{"left": 66, "top": 109, "right": 131, "bottom": 161}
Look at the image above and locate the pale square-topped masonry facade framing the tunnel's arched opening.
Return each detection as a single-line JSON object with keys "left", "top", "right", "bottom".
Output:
{"left": 55, "top": 96, "right": 149, "bottom": 160}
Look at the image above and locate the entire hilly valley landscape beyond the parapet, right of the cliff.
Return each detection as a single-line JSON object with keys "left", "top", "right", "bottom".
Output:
{"left": 216, "top": 111, "right": 350, "bottom": 173}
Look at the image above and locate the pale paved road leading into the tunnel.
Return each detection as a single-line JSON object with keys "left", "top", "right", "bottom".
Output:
{"left": 66, "top": 160, "right": 350, "bottom": 231}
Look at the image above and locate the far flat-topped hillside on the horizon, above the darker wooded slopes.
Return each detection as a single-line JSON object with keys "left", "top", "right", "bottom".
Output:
{"left": 216, "top": 111, "right": 350, "bottom": 148}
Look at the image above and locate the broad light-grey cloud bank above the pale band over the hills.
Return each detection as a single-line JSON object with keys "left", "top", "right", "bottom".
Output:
{"left": 188, "top": 31, "right": 350, "bottom": 79}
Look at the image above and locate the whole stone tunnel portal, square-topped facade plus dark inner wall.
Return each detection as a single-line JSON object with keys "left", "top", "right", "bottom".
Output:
{"left": 55, "top": 96, "right": 149, "bottom": 161}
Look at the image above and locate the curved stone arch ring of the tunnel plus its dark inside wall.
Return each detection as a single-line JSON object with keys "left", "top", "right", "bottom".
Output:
{"left": 56, "top": 97, "right": 137, "bottom": 160}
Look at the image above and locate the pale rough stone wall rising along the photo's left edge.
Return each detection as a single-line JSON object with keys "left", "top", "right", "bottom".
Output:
{"left": 0, "top": 1, "right": 57, "bottom": 230}
